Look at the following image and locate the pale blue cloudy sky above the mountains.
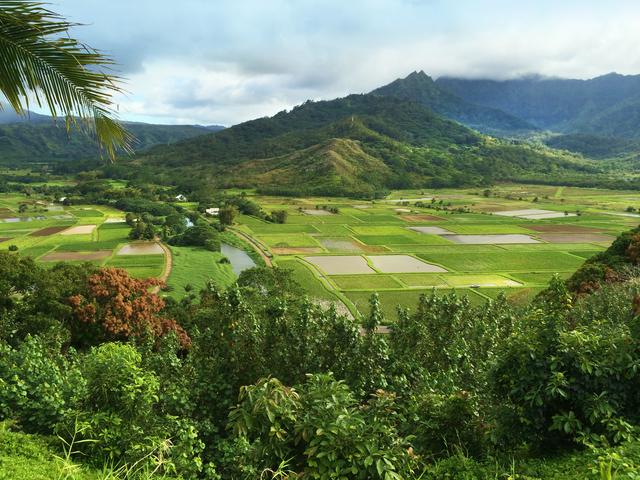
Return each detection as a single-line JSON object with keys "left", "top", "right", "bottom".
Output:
{"left": 49, "top": 0, "right": 640, "bottom": 126}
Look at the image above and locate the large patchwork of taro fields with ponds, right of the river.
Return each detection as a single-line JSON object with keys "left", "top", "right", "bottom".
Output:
{"left": 237, "top": 185, "right": 640, "bottom": 319}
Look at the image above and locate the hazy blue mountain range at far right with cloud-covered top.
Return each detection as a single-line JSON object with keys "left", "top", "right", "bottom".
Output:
{"left": 435, "top": 73, "right": 640, "bottom": 139}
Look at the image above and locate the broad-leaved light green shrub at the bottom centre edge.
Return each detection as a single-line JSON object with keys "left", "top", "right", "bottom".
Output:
{"left": 230, "top": 375, "right": 413, "bottom": 479}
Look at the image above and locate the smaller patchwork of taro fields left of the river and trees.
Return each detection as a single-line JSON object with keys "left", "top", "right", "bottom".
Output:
{"left": 0, "top": 194, "right": 165, "bottom": 278}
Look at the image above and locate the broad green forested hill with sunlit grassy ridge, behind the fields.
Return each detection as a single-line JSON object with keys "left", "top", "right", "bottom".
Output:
{"left": 135, "top": 95, "right": 599, "bottom": 196}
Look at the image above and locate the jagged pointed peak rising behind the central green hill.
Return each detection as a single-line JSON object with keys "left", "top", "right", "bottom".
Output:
{"left": 371, "top": 71, "right": 537, "bottom": 135}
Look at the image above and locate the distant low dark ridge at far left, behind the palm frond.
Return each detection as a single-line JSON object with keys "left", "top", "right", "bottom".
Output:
{"left": 0, "top": 115, "right": 219, "bottom": 164}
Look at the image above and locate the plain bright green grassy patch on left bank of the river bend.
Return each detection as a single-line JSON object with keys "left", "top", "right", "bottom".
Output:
{"left": 167, "top": 246, "right": 236, "bottom": 299}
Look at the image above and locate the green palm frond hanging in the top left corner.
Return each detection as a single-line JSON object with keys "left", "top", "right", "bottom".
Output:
{"left": 0, "top": 0, "right": 133, "bottom": 159}
